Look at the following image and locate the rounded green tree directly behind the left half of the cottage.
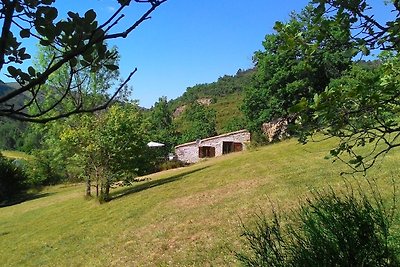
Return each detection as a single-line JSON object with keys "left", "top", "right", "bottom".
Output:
{"left": 180, "top": 102, "right": 217, "bottom": 143}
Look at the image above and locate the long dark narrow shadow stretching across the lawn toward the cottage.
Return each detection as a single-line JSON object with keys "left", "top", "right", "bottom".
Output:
{"left": 109, "top": 167, "right": 208, "bottom": 201}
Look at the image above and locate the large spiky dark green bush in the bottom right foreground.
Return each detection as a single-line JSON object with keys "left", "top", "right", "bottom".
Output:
{"left": 236, "top": 185, "right": 400, "bottom": 266}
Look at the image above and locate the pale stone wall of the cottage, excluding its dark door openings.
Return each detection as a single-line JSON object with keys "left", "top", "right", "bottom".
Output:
{"left": 175, "top": 131, "right": 250, "bottom": 163}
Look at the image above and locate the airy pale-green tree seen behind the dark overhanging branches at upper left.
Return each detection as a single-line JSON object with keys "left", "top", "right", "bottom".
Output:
{"left": 27, "top": 42, "right": 128, "bottom": 118}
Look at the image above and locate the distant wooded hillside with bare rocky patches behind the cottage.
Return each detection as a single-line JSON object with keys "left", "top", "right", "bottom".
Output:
{"left": 169, "top": 68, "right": 255, "bottom": 134}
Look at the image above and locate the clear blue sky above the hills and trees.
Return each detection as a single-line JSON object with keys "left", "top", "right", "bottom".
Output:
{"left": 2, "top": 0, "right": 387, "bottom": 107}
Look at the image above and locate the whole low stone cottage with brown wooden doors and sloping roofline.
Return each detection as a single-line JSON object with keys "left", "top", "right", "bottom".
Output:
{"left": 175, "top": 130, "right": 250, "bottom": 163}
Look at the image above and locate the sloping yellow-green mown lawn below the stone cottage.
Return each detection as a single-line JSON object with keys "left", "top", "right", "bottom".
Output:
{"left": 0, "top": 140, "right": 400, "bottom": 266}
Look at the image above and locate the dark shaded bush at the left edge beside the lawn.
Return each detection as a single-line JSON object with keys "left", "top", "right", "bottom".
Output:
{"left": 0, "top": 154, "right": 27, "bottom": 204}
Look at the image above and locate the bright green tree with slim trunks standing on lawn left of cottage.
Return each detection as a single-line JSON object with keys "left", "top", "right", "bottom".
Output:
{"left": 60, "top": 104, "right": 151, "bottom": 200}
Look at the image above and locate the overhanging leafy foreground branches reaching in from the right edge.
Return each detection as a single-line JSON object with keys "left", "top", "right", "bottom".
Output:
{"left": 294, "top": 0, "right": 400, "bottom": 172}
